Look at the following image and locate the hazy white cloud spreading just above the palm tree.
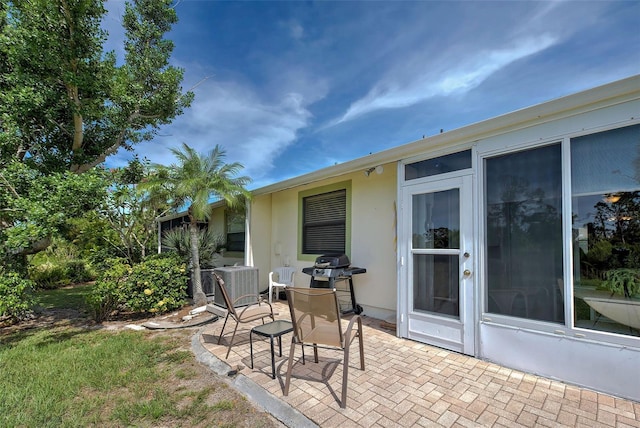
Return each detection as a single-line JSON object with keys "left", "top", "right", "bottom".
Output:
{"left": 138, "top": 79, "right": 311, "bottom": 180}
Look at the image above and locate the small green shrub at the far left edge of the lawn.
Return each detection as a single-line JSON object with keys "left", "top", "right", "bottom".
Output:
{"left": 0, "top": 269, "right": 34, "bottom": 321}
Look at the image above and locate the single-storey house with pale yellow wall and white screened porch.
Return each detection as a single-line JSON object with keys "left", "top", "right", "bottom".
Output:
{"left": 159, "top": 75, "right": 640, "bottom": 401}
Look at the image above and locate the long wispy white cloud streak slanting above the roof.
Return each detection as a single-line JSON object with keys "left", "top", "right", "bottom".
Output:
{"left": 333, "top": 34, "right": 557, "bottom": 124}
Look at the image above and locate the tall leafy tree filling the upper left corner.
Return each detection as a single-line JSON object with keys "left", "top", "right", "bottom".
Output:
{"left": 0, "top": 0, "right": 193, "bottom": 173}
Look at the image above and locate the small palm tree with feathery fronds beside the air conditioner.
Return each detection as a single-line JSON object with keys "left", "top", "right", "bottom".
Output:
{"left": 143, "top": 143, "right": 251, "bottom": 306}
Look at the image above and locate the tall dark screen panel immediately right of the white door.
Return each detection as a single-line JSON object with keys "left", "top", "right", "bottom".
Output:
{"left": 485, "top": 144, "right": 564, "bottom": 323}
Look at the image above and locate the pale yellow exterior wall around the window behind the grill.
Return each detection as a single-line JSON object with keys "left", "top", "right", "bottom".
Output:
{"left": 250, "top": 163, "right": 397, "bottom": 319}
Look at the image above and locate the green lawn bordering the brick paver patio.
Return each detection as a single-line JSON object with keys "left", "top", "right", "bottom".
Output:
{"left": 0, "top": 288, "right": 272, "bottom": 427}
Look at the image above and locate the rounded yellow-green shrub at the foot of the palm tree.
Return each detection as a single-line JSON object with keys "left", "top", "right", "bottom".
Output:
{"left": 87, "top": 255, "right": 187, "bottom": 321}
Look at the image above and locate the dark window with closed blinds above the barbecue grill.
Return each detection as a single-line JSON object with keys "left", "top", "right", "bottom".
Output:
{"left": 302, "top": 189, "right": 347, "bottom": 254}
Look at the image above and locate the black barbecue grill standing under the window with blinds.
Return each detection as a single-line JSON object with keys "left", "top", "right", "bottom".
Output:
{"left": 302, "top": 254, "right": 367, "bottom": 314}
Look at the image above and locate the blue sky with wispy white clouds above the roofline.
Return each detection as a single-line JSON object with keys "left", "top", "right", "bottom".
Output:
{"left": 105, "top": 0, "right": 640, "bottom": 189}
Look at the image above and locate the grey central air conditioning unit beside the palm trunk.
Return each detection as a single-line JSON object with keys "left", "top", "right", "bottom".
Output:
{"left": 213, "top": 266, "right": 259, "bottom": 308}
